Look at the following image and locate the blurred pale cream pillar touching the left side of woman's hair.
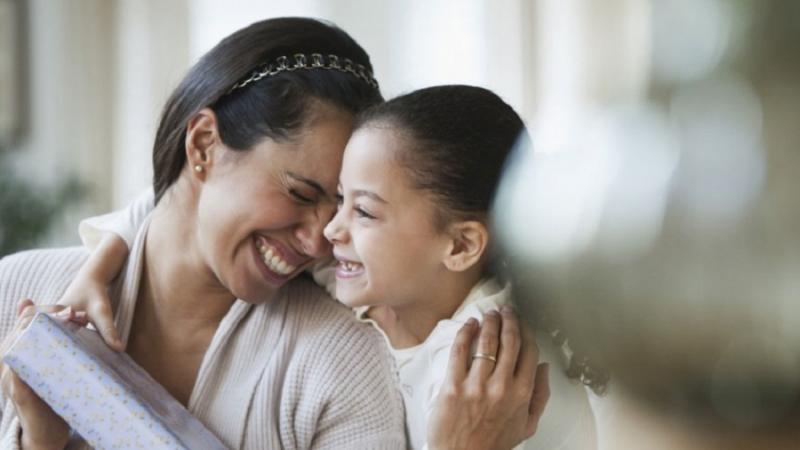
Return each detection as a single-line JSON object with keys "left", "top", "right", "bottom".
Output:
{"left": 111, "top": 0, "right": 189, "bottom": 208}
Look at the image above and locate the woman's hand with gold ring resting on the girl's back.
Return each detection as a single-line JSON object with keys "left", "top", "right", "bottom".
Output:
{"left": 428, "top": 308, "right": 550, "bottom": 450}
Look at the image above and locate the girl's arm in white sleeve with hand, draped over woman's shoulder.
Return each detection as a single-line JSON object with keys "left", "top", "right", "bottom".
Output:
{"left": 58, "top": 189, "right": 153, "bottom": 350}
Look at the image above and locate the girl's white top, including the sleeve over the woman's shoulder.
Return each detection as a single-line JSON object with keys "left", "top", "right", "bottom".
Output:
{"left": 79, "top": 190, "right": 597, "bottom": 450}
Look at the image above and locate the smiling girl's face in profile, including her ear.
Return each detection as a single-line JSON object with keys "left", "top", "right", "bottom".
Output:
{"left": 325, "top": 126, "right": 449, "bottom": 307}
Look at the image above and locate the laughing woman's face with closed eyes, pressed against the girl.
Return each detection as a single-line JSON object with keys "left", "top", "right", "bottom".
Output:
{"left": 196, "top": 105, "right": 352, "bottom": 302}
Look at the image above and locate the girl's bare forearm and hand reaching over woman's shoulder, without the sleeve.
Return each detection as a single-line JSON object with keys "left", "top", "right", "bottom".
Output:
{"left": 58, "top": 233, "right": 128, "bottom": 351}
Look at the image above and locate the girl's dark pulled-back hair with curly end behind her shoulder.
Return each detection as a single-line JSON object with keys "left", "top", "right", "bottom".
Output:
{"left": 356, "top": 86, "right": 608, "bottom": 393}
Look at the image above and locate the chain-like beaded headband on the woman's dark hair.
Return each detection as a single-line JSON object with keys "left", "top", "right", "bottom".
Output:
{"left": 228, "top": 53, "right": 378, "bottom": 93}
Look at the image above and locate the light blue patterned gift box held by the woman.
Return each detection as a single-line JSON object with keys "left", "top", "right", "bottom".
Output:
{"left": 3, "top": 313, "right": 225, "bottom": 450}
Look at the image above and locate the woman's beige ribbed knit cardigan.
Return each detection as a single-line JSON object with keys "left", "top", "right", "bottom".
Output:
{"left": 0, "top": 227, "right": 406, "bottom": 449}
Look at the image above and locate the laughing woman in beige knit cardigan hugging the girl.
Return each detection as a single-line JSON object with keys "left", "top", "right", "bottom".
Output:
{"left": 0, "top": 15, "right": 535, "bottom": 449}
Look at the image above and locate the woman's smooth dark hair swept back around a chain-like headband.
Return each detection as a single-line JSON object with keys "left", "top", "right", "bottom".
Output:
{"left": 153, "top": 18, "right": 383, "bottom": 201}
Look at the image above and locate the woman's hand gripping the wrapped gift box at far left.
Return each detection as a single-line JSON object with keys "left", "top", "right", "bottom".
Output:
{"left": 0, "top": 299, "right": 86, "bottom": 450}
